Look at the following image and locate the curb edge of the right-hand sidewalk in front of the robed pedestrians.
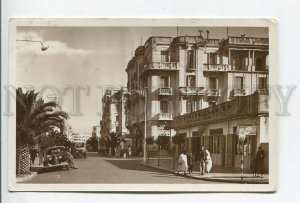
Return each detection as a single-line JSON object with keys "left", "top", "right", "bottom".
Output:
{"left": 139, "top": 162, "right": 269, "bottom": 184}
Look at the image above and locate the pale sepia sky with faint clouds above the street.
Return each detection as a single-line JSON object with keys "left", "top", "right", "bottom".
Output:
{"left": 16, "top": 26, "right": 268, "bottom": 133}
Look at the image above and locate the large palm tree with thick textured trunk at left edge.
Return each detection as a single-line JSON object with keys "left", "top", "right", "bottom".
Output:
{"left": 16, "top": 88, "right": 68, "bottom": 175}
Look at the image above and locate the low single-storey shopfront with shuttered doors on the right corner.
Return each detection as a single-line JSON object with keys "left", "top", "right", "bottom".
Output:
{"left": 174, "top": 95, "right": 269, "bottom": 171}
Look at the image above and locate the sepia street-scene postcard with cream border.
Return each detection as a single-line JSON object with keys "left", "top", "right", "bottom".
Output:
{"left": 6, "top": 18, "right": 277, "bottom": 192}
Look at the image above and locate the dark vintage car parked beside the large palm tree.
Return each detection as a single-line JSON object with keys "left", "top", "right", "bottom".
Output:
{"left": 44, "top": 146, "right": 70, "bottom": 169}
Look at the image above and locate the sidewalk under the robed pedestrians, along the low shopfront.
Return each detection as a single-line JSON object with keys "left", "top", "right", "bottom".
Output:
{"left": 140, "top": 157, "right": 269, "bottom": 184}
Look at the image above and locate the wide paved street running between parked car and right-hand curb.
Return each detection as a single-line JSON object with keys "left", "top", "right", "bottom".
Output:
{"left": 29, "top": 157, "right": 212, "bottom": 184}
